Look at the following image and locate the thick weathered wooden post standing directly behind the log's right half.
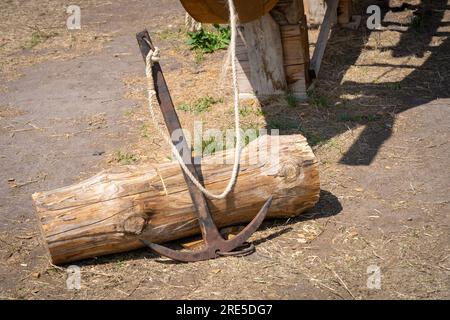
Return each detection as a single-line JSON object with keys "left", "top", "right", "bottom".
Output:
{"left": 236, "top": 0, "right": 309, "bottom": 99}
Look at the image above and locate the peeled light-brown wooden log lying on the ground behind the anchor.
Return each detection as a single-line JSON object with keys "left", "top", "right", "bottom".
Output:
{"left": 33, "top": 135, "right": 320, "bottom": 264}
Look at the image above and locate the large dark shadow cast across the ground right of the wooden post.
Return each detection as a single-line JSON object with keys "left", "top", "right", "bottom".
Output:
{"left": 263, "top": 0, "right": 450, "bottom": 166}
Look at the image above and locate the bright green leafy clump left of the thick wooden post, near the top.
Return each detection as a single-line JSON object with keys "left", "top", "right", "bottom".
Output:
{"left": 186, "top": 24, "right": 231, "bottom": 53}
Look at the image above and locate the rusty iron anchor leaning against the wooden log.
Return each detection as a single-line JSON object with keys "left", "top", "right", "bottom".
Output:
{"left": 136, "top": 30, "right": 272, "bottom": 262}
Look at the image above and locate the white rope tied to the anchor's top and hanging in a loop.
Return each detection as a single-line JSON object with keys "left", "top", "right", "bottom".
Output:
{"left": 145, "top": 0, "right": 242, "bottom": 200}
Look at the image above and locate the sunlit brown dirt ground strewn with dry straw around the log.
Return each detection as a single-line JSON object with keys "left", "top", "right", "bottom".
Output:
{"left": 0, "top": 0, "right": 450, "bottom": 299}
